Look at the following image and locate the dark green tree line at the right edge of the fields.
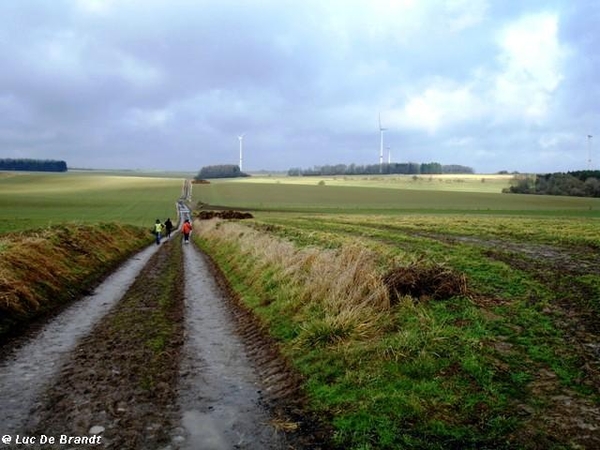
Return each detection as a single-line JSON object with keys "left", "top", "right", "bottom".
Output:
{"left": 503, "top": 170, "right": 600, "bottom": 197}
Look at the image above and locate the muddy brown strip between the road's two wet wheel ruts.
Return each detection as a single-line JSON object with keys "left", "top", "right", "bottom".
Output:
{"left": 28, "top": 237, "right": 183, "bottom": 449}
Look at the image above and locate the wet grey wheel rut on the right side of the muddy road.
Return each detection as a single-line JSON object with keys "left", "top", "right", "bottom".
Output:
{"left": 173, "top": 245, "right": 287, "bottom": 450}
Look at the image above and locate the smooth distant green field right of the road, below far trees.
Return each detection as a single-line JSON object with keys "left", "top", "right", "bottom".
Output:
{"left": 194, "top": 177, "right": 600, "bottom": 217}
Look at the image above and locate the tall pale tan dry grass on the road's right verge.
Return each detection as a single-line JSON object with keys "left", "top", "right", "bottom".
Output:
{"left": 194, "top": 220, "right": 390, "bottom": 344}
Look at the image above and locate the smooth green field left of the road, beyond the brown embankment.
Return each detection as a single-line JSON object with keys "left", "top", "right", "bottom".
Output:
{"left": 0, "top": 172, "right": 183, "bottom": 233}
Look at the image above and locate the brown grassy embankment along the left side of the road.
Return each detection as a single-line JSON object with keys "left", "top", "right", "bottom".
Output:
{"left": 0, "top": 223, "right": 152, "bottom": 336}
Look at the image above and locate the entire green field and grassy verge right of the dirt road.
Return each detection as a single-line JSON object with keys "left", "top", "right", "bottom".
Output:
{"left": 194, "top": 177, "right": 600, "bottom": 449}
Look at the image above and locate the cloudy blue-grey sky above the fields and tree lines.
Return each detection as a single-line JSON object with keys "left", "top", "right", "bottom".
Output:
{"left": 0, "top": 0, "right": 600, "bottom": 173}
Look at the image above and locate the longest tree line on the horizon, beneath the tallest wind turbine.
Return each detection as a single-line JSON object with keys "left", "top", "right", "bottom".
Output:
{"left": 288, "top": 162, "right": 474, "bottom": 176}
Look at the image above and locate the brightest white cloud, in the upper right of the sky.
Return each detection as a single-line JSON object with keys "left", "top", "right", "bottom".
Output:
{"left": 394, "top": 10, "right": 566, "bottom": 134}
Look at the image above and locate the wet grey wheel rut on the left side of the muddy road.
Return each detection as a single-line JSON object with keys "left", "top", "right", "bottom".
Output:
{"left": 0, "top": 245, "right": 158, "bottom": 435}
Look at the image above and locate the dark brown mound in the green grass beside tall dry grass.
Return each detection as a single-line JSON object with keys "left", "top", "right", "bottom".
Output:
{"left": 383, "top": 262, "right": 468, "bottom": 305}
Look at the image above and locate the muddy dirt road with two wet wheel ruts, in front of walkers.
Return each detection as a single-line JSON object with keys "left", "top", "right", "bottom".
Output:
{"left": 0, "top": 232, "right": 324, "bottom": 450}
